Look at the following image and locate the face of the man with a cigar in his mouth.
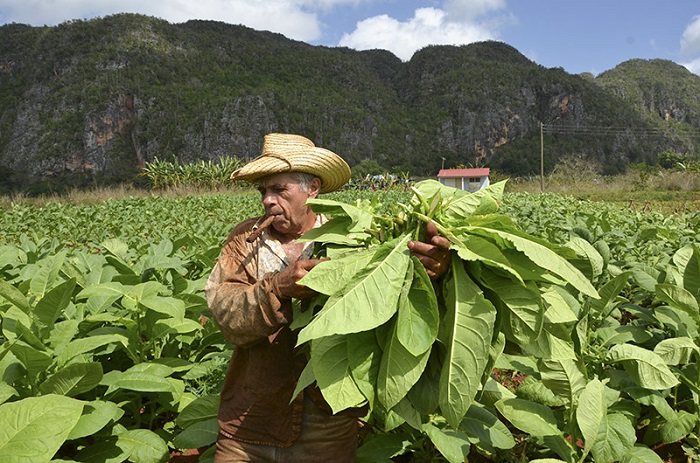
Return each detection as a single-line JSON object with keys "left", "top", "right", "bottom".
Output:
{"left": 258, "top": 173, "right": 321, "bottom": 236}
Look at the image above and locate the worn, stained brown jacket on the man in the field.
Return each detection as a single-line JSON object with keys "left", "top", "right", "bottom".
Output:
{"left": 205, "top": 218, "right": 362, "bottom": 447}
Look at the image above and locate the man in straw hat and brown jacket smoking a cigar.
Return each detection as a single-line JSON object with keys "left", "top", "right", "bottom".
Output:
{"left": 206, "top": 134, "right": 450, "bottom": 463}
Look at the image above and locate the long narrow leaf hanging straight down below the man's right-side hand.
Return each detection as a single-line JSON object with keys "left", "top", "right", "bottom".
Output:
{"left": 440, "top": 259, "right": 496, "bottom": 428}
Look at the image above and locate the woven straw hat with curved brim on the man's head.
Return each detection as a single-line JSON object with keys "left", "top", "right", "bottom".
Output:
{"left": 231, "top": 133, "right": 351, "bottom": 193}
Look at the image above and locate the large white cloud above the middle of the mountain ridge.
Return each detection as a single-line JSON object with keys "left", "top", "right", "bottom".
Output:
{"left": 339, "top": 0, "right": 505, "bottom": 61}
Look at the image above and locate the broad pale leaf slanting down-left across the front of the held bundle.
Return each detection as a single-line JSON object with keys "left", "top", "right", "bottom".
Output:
{"left": 298, "top": 235, "right": 411, "bottom": 344}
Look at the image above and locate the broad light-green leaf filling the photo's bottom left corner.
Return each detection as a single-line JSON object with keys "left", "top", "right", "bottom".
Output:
{"left": 0, "top": 394, "right": 84, "bottom": 463}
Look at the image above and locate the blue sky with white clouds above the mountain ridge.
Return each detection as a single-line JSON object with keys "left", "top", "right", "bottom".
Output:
{"left": 0, "top": 0, "right": 700, "bottom": 75}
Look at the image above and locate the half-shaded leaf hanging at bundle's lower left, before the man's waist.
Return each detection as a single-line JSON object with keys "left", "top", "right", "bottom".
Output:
{"left": 311, "top": 336, "right": 366, "bottom": 413}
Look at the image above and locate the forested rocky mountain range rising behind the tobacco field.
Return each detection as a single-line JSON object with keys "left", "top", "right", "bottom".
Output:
{"left": 0, "top": 14, "right": 700, "bottom": 191}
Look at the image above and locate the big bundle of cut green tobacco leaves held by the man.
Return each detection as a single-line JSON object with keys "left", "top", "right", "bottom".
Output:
{"left": 288, "top": 181, "right": 597, "bottom": 461}
